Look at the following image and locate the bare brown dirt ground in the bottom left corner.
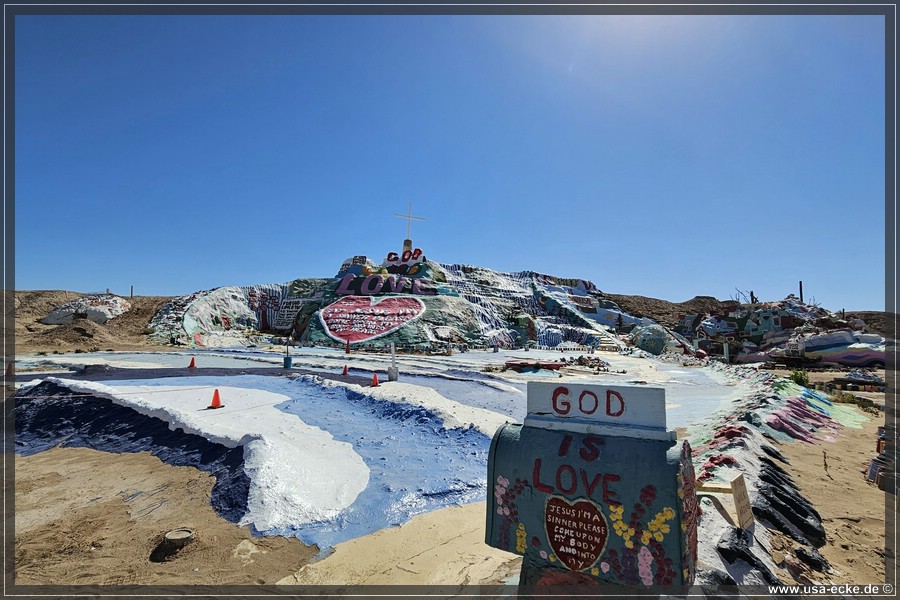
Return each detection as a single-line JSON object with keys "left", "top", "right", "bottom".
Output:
{"left": 15, "top": 448, "right": 316, "bottom": 586}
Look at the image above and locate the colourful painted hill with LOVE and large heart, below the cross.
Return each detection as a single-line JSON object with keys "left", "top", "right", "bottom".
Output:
{"left": 151, "top": 248, "right": 636, "bottom": 349}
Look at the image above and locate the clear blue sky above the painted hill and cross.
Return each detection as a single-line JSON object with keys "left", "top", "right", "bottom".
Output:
{"left": 14, "top": 15, "right": 885, "bottom": 310}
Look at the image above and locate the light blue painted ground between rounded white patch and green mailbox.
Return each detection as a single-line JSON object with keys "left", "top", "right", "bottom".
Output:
{"left": 272, "top": 380, "right": 490, "bottom": 548}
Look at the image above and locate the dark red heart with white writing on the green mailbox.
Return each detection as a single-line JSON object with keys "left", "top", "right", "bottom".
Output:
{"left": 544, "top": 496, "right": 609, "bottom": 571}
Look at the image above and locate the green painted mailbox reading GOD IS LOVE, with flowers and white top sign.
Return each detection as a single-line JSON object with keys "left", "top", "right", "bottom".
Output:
{"left": 485, "top": 382, "right": 699, "bottom": 586}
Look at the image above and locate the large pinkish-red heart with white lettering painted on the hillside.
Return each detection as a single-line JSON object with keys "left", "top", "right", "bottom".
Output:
{"left": 319, "top": 296, "right": 425, "bottom": 344}
